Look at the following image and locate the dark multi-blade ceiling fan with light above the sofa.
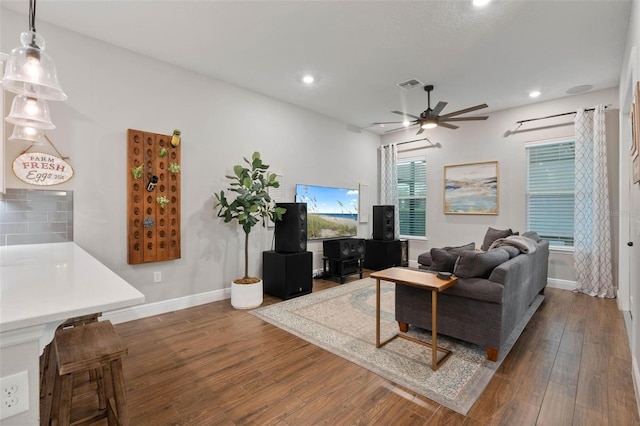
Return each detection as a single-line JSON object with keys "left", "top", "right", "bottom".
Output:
{"left": 373, "top": 84, "right": 489, "bottom": 135}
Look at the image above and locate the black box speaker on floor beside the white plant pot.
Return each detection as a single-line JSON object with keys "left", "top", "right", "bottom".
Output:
{"left": 262, "top": 251, "right": 313, "bottom": 300}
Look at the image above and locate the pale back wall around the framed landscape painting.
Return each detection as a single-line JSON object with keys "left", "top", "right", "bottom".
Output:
{"left": 382, "top": 89, "right": 618, "bottom": 281}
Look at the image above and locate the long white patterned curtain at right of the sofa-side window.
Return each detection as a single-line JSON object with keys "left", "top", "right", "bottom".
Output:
{"left": 574, "top": 105, "right": 615, "bottom": 297}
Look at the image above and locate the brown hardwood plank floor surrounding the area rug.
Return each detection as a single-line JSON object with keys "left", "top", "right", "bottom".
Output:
{"left": 66, "top": 276, "right": 640, "bottom": 426}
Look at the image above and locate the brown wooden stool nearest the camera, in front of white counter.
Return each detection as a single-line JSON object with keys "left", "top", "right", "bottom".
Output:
{"left": 51, "top": 321, "right": 128, "bottom": 425}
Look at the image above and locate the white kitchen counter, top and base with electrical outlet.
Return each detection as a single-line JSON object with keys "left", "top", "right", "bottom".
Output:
{"left": 0, "top": 242, "right": 144, "bottom": 425}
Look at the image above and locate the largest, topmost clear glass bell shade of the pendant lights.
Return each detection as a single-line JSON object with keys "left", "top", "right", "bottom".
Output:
{"left": 2, "top": 31, "right": 67, "bottom": 101}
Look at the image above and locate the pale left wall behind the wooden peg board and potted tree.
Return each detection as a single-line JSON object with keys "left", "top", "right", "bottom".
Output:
{"left": 0, "top": 10, "right": 379, "bottom": 303}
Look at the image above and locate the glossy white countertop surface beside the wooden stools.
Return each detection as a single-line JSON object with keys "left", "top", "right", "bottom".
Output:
{"left": 0, "top": 242, "right": 144, "bottom": 332}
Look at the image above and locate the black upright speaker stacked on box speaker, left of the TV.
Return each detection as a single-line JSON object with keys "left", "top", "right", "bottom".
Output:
{"left": 275, "top": 203, "right": 307, "bottom": 253}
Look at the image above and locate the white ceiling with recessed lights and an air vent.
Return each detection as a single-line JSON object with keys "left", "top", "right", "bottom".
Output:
{"left": 0, "top": 0, "right": 631, "bottom": 133}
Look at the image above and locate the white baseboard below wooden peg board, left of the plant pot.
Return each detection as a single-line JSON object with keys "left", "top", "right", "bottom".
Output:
{"left": 102, "top": 288, "right": 231, "bottom": 324}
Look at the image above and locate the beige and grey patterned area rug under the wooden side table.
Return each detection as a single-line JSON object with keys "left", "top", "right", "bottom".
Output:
{"left": 251, "top": 278, "right": 543, "bottom": 415}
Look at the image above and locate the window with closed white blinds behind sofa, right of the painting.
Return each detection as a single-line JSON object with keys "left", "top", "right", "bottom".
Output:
{"left": 526, "top": 141, "right": 575, "bottom": 247}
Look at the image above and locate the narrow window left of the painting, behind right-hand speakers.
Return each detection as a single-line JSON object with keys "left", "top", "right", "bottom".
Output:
{"left": 398, "top": 158, "right": 427, "bottom": 237}
